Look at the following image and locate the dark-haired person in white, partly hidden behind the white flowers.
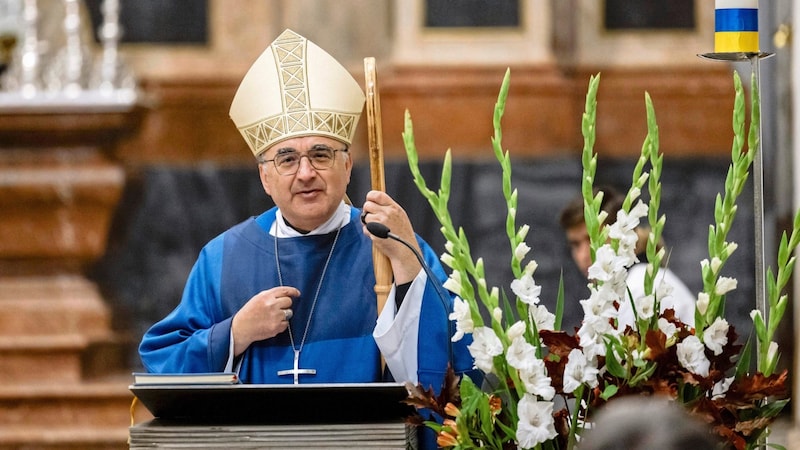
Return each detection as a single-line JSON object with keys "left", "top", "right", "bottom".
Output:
{"left": 559, "top": 186, "right": 695, "bottom": 327}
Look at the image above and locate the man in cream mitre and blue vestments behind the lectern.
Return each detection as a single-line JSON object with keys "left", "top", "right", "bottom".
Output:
{"left": 139, "top": 30, "right": 473, "bottom": 446}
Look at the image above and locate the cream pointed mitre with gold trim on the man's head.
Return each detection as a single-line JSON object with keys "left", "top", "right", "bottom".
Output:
{"left": 230, "top": 29, "right": 364, "bottom": 156}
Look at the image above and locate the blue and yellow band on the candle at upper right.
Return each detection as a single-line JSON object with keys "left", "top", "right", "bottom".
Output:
{"left": 714, "top": 0, "right": 759, "bottom": 53}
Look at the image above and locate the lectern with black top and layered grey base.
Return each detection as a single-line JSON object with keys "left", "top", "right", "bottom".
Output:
{"left": 129, "top": 383, "right": 417, "bottom": 450}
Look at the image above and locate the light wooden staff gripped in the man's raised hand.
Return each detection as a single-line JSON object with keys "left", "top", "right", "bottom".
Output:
{"left": 364, "top": 57, "right": 392, "bottom": 315}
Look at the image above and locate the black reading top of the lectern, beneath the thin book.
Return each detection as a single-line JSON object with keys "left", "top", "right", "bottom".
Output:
{"left": 130, "top": 379, "right": 415, "bottom": 424}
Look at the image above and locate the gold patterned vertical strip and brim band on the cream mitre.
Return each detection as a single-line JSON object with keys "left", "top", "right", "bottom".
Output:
{"left": 240, "top": 30, "right": 360, "bottom": 155}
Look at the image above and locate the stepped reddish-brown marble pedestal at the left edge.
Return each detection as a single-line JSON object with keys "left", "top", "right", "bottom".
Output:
{"left": 0, "top": 94, "right": 140, "bottom": 448}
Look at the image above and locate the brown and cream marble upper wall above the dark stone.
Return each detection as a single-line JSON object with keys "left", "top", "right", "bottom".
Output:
{"left": 109, "top": 0, "right": 732, "bottom": 165}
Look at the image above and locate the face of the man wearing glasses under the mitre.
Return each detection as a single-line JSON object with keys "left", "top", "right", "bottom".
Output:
{"left": 258, "top": 136, "right": 353, "bottom": 231}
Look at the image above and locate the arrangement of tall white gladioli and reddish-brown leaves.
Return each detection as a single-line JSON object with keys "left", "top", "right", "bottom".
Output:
{"left": 403, "top": 67, "right": 800, "bottom": 449}
